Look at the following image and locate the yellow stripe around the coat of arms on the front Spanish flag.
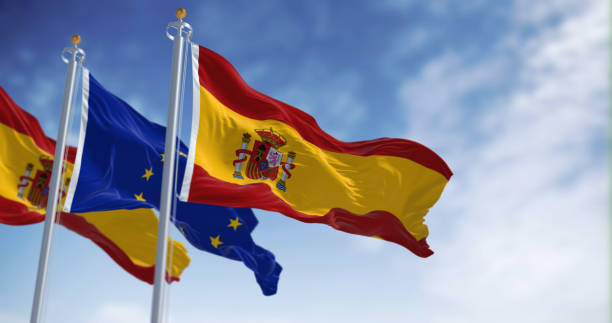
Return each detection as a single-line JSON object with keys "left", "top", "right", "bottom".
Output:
{"left": 195, "top": 87, "right": 447, "bottom": 240}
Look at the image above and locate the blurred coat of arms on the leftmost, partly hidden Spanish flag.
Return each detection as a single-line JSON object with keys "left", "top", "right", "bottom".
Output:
{"left": 17, "top": 155, "right": 70, "bottom": 209}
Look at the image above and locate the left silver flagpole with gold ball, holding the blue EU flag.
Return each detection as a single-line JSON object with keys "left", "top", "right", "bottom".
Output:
{"left": 30, "top": 35, "right": 85, "bottom": 323}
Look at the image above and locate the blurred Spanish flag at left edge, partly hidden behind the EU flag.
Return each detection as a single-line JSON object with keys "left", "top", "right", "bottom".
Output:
{"left": 0, "top": 87, "right": 190, "bottom": 284}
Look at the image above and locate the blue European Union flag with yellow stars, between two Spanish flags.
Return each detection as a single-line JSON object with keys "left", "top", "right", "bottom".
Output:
{"left": 65, "top": 69, "right": 282, "bottom": 295}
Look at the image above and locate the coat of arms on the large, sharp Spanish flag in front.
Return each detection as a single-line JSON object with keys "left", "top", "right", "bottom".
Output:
{"left": 234, "top": 128, "right": 296, "bottom": 191}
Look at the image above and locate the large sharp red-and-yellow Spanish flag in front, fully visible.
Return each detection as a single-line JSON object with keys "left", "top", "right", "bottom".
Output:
{"left": 181, "top": 45, "right": 452, "bottom": 257}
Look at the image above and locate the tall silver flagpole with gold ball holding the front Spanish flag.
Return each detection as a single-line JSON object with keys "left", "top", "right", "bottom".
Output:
{"left": 151, "top": 8, "right": 192, "bottom": 323}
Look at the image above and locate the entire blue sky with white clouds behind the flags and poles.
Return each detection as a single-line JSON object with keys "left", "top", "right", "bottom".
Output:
{"left": 0, "top": 0, "right": 610, "bottom": 322}
